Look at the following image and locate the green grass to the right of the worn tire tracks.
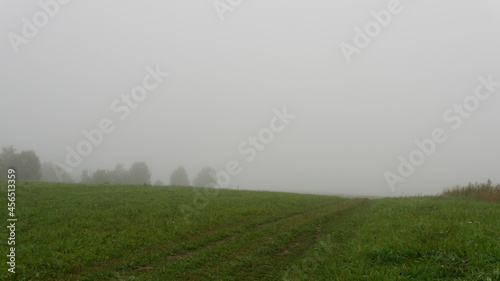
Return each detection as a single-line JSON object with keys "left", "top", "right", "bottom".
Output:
{"left": 290, "top": 197, "right": 500, "bottom": 280}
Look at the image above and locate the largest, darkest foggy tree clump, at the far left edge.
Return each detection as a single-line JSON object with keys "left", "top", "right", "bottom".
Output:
{"left": 0, "top": 146, "right": 41, "bottom": 181}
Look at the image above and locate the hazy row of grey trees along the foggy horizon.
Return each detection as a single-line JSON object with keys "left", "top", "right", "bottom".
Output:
{"left": 0, "top": 146, "right": 219, "bottom": 187}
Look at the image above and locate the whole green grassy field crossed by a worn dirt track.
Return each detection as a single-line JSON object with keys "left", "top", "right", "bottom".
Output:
{"left": 0, "top": 182, "right": 500, "bottom": 280}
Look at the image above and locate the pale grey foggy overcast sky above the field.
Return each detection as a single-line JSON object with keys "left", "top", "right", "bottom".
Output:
{"left": 0, "top": 0, "right": 500, "bottom": 196}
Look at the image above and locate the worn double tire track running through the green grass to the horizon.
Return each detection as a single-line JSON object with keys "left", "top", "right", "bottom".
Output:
{"left": 134, "top": 200, "right": 372, "bottom": 280}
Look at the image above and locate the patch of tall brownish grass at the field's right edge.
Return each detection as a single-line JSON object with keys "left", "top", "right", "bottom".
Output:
{"left": 443, "top": 180, "right": 500, "bottom": 202}
